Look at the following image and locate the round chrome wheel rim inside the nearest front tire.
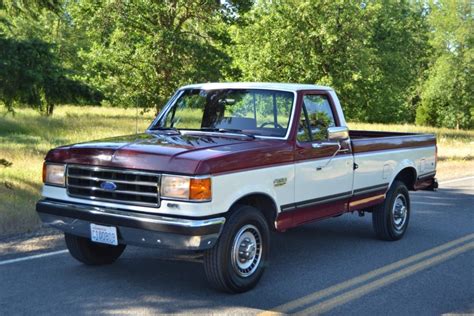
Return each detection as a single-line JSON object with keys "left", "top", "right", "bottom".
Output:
{"left": 231, "top": 224, "right": 262, "bottom": 278}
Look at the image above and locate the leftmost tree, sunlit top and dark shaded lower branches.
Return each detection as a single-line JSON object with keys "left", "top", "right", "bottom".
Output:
{"left": 0, "top": 0, "right": 101, "bottom": 115}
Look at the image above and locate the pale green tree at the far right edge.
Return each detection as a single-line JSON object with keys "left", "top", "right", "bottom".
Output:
{"left": 416, "top": 1, "right": 474, "bottom": 129}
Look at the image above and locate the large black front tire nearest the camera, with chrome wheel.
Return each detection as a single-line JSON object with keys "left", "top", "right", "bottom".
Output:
{"left": 204, "top": 205, "right": 270, "bottom": 293}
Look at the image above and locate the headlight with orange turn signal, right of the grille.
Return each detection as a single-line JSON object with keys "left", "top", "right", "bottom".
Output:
{"left": 161, "top": 175, "right": 212, "bottom": 201}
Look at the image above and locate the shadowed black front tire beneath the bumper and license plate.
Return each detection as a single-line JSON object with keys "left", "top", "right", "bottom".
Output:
{"left": 64, "top": 233, "right": 125, "bottom": 265}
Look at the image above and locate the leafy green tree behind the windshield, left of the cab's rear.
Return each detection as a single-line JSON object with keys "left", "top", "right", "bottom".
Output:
{"left": 71, "top": 0, "right": 250, "bottom": 110}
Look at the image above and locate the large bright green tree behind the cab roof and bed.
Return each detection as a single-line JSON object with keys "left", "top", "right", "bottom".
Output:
{"left": 229, "top": 0, "right": 426, "bottom": 122}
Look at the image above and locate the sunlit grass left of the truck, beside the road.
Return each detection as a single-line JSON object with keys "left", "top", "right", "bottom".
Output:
{"left": 0, "top": 106, "right": 153, "bottom": 234}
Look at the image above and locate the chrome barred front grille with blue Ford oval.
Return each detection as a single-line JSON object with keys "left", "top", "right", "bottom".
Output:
{"left": 66, "top": 165, "right": 160, "bottom": 207}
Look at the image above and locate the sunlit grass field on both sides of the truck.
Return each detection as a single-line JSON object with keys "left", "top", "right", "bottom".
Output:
{"left": 0, "top": 106, "right": 474, "bottom": 235}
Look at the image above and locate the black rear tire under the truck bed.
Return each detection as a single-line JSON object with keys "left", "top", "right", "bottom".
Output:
{"left": 372, "top": 181, "right": 411, "bottom": 241}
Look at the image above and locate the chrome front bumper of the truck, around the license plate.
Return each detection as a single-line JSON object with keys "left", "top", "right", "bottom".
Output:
{"left": 36, "top": 199, "right": 225, "bottom": 250}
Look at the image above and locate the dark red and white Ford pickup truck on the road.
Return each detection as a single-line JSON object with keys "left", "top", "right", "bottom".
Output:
{"left": 37, "top": 83, "right": 437, "bottom": 292}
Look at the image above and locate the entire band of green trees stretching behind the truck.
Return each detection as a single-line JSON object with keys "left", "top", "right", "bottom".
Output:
{"left": 0, "top": 0, "right": 474, "bottom": 128}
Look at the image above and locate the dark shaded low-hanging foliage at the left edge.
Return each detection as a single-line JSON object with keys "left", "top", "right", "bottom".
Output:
{"left": 0, "top": 37, "right": 100, "bottom": 115}
